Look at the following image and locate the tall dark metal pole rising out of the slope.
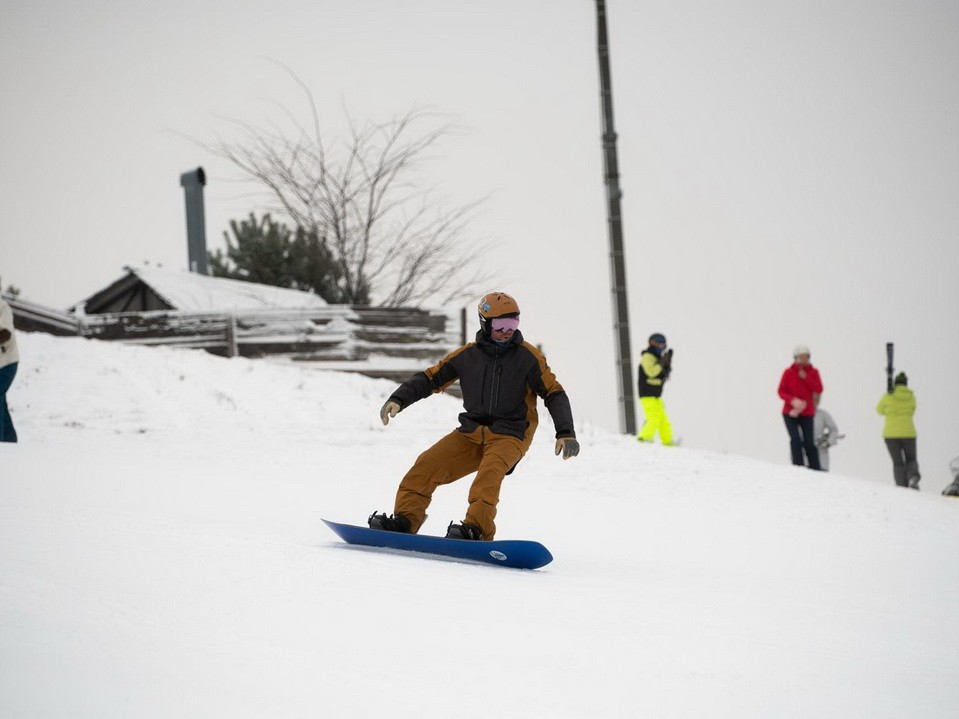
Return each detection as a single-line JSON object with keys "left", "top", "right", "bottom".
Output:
{"left": 596, "top": 0, "right": 636, "bottom": 434}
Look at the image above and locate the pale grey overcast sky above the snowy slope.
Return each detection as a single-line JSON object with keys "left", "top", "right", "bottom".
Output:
{"left": 0, "top": 0, "right": 959, "bottom": 491}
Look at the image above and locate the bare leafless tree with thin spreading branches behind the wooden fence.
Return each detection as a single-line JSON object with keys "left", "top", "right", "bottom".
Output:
{"left": 200, "top": 66, "right": 487, "bottom": 306}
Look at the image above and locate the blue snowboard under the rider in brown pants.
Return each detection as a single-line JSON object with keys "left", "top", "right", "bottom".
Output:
{"left": 323, "top": 519, "right": 553, "bottom": 569}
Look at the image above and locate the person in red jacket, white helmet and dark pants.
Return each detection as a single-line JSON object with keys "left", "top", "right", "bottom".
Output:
{"left": 779, "top": 345, "right": 822, "bottom": 469}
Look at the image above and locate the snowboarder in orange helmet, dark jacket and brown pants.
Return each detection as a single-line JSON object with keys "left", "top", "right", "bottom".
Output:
{"left": 368, "top": 292, "right": 579, "bottom": 541}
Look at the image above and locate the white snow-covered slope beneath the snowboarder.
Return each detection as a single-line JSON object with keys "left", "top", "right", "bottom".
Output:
{"left": 0, "top": 334, "right": 959, "bottom": 718}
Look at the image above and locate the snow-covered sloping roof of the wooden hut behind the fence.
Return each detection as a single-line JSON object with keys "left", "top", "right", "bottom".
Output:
{"left": 126, "top": 267, "right": 327, "bottom": 312}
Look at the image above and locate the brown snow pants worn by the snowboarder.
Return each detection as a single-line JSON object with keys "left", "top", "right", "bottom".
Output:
{"left": 393, "top": 427, "right": 529, "bottom": 540}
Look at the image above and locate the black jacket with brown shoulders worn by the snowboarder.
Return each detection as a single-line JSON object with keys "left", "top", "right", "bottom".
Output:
{"left": 390, "top": 330, "right": 576, "bottom": 442}
